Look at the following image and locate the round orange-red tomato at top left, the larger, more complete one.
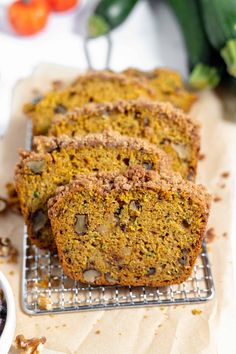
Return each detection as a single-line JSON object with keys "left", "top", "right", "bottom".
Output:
{"left": 8, "top": 0, "right": 49, "bottom": 36}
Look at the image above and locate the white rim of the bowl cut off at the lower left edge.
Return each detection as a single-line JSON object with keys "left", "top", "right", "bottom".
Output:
{"left": 0, "top": 272, "right": 16, "bottom": 354}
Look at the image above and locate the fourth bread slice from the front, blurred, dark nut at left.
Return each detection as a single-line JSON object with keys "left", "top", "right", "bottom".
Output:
{"left": 24, "top": 71, "right": 156, "bottom": 135}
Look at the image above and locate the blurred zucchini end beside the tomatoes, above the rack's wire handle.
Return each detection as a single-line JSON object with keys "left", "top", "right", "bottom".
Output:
{"left": 88, "top": 0, "right": 138, "bottom": 37}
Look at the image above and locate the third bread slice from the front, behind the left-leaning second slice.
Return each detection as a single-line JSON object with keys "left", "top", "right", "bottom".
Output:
{"left": 49, "top": 100, "right": 200, "bottom": 180}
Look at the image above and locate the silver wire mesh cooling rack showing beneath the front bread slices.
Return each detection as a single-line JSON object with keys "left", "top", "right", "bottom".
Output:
{"left": 22, "top": 230, "right": 214, "bottom": 314}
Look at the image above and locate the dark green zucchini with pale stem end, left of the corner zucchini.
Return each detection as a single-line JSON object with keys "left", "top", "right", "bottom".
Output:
{"left": 169, "top": 0, "right": 220, "bottom": 89}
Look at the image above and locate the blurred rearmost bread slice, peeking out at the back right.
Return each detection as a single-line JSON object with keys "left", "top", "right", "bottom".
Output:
{"left": 123, "top": 68, "right": 196, "bottom": 112}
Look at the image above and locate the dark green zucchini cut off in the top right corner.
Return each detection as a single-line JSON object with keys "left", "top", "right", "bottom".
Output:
{"left": 200, "top": 0, "right": 236, "bottom": 77}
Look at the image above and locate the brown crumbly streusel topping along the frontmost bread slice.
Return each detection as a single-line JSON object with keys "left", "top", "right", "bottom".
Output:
{"left": 49, "top": 166, "right": 212, "bottom": 211}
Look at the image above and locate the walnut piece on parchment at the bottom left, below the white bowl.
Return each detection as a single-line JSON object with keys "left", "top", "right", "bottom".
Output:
{"left": 15, "top": 334, "right": 46, "bottom": 354}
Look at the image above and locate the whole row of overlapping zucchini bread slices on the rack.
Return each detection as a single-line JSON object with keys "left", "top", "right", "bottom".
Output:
{"left": 16, "top": 69, "right": 210, "bottom": 286}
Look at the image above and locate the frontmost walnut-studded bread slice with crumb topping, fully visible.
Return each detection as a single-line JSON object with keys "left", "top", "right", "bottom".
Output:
{"left": 48, "top": 167, "right": 210, "bottom": 286}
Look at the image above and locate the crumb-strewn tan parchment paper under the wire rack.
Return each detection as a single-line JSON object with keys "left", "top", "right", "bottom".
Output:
{"left": 0, "top": 64, "right": 236, "bottom": 354}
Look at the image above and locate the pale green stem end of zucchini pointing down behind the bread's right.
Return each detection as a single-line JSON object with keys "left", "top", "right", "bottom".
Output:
{"left": 189, "top": 63, "right": 220, "bottom": 90}
